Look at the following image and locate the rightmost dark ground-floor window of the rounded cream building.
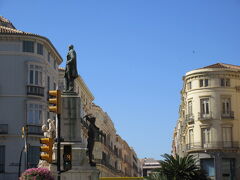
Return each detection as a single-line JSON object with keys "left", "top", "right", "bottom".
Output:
{"left": 222, "top": 158, "right": 235, "bottom": 180}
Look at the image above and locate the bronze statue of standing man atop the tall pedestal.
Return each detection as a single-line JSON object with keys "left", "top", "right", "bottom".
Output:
{"left": 64, "top": 45, "right": 78, "bottom": 92}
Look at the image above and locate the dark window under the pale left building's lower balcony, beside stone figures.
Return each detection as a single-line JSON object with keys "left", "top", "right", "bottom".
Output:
{"left": 28, "top": 146, "right": 40, "bottom": 168}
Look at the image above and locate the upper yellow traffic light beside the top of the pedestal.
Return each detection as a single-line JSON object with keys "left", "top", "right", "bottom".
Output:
{"left": 48, "top": 90, "right": 61, "bottom": 114}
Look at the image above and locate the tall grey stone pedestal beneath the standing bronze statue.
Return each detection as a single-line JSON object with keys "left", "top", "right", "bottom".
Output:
{"left": 50, "top": 92, "right": 99, "bottom": 180}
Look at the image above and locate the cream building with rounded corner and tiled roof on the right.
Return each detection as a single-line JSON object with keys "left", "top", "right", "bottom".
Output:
{"left": 172, "top": 63, "right": 240, "bottom": 180}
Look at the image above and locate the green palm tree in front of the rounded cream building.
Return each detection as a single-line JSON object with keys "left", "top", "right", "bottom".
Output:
{"left": 149, "top": 154, "right": 207, "bottom": 180}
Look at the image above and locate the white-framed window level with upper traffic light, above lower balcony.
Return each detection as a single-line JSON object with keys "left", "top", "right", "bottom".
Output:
{"left": 27, "top": 103, "right": 43, "bottom": 125}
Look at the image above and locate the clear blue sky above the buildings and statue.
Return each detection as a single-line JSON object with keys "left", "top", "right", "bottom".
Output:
{"left": 0, "top": 0, "right": 240, "bottom": 159}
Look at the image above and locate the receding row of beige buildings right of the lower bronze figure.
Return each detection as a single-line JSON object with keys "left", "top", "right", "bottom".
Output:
{"left": 92, "top": 104, "right": 141, "bottom": 177}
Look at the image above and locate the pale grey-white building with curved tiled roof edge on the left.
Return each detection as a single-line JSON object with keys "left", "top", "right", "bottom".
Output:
{"left": 0, "top": 17, "right": 62, "bottom": 180}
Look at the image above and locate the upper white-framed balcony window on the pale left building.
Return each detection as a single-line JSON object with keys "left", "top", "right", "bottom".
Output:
{"left": 28, "top": 64, "right": 43, "bottom": 86}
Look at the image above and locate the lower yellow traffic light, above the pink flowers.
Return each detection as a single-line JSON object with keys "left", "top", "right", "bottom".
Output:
{"left": 40, "top": 138, "right": 53, "bottom": 163}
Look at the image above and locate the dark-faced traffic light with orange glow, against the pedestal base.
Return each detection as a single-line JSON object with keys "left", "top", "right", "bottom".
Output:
{"left": 63, "top": 145, "right": 72, "bottom": 171}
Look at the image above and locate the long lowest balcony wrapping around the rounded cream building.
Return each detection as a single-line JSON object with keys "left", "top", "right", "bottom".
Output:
{"left": 186, "top": 141, "right": 240, "bottom": 151}
